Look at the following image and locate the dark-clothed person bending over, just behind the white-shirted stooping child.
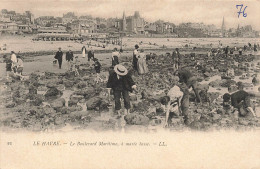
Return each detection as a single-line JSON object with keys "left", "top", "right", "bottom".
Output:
{"left": 177, "top": 68, "right": 201, "bottom": 124}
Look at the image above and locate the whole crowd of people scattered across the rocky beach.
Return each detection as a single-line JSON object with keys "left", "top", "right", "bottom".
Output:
{"left": 5, "top": 41, "right": 259, "bottom": 126}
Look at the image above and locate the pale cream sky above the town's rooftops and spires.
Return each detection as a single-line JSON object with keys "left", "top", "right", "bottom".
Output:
{"left": 0, "top": 0, "right": 260, "bottom": 30}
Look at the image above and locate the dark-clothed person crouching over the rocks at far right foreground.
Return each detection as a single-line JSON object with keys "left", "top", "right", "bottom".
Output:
{"left": 223, "top": 83, "right": 257, "bottom": 117}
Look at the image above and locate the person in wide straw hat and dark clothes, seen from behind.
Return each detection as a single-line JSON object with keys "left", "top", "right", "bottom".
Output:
{"left": 107, "top": 64, "right": 136, "bottom": 115}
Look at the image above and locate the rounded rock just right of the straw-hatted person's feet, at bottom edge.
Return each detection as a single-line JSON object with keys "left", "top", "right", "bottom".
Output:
{"left": 124, "top": 113, "right": 149, "bottom": 125}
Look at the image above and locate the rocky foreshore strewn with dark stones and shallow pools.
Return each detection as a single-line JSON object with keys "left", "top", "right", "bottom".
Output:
{"left": 1, "top": 49, "right": 260, "bottom": 131}
